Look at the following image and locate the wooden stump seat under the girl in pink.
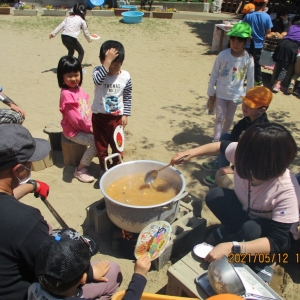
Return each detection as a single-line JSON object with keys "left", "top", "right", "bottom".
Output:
{"left": 61, "top": 134, "right": 87, "bottom": 167}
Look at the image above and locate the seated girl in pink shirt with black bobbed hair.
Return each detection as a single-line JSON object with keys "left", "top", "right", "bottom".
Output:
{"left": 57, "top": 56, "right": 97, "bottom": 182}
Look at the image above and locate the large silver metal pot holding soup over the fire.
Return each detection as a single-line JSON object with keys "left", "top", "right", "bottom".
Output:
{"left": 100, "top": 155, "right": 185, "bottom": 233}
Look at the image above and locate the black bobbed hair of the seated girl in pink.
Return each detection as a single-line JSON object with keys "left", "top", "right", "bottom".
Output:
{"left": 57, "top": 55, "right": 82, "bottom": 88}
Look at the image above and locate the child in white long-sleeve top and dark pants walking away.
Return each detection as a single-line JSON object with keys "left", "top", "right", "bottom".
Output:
{"left": 49, "top": 3, "right": 92, "bottom": 63}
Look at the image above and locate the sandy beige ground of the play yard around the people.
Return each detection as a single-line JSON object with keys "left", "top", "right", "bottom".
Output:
{"left": 0, "top": 16, "right": 300, "bottom": 299}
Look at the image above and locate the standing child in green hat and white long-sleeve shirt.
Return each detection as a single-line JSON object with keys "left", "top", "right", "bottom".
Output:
{"left": 207, "top": 22, "right": 254, "bottom": 151}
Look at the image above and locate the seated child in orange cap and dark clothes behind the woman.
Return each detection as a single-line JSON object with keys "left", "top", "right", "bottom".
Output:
{"left": 202, "top": 86, "right": 273, "bottom": 186}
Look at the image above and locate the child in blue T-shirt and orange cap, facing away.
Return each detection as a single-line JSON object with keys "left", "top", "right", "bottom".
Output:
{"left": 243, "top": 0, "right": 273, "bottom": 86}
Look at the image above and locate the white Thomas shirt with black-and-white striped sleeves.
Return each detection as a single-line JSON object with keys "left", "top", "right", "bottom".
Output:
{"left": 92, "top": 66, "right": 132, "bottom": 116}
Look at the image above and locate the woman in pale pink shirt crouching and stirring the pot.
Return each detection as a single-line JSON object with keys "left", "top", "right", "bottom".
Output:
{"left": 171, "top": 122, "right": 300, "bottom": 282}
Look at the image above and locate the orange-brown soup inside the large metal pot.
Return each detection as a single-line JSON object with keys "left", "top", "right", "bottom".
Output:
{"left": 106, "top": 174, "right": 179, "bottom": 206}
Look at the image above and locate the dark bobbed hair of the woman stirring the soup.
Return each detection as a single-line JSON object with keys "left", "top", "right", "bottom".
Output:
{"left": 235, "top": 123, "right": 297, "bottom": 181}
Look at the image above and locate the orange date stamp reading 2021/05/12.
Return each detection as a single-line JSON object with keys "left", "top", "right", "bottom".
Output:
{"left": 228, "top": 253, "right": 300, "bottom": 264}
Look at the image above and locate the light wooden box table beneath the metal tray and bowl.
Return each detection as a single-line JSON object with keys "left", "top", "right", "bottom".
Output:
{"left": 167, "top": 252, "right": 209, "bottom": 299}
